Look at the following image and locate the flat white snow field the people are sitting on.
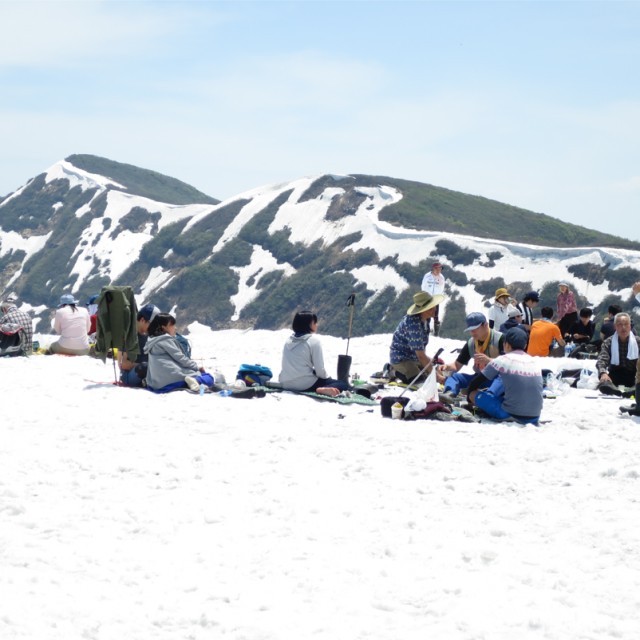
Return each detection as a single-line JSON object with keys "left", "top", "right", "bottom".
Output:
{"left": 0, "top": 324, "right": 640, "bottom": 640}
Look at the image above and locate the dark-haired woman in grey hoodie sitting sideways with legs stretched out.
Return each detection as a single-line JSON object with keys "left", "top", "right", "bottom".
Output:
{"left": 144, "top": 313, "right": 215, "bottom": 393}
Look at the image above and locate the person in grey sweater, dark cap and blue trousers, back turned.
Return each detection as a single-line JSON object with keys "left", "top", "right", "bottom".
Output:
{"left": 468, "top": 328, "right": 543, "bottom": 424}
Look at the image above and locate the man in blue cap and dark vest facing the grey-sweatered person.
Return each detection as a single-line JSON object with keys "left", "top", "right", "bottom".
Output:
{"left": 438, "top": 311, "right": 502, "bottom": 402}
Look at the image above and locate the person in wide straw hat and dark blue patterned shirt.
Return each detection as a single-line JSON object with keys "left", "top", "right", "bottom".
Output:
{"left": 389, "top": 291, "right": 444, "bottom": 382}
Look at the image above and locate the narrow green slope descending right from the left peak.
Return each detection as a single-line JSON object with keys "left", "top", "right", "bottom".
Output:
{"left": 65, "top": 154, "right": 220, "bottom": 204}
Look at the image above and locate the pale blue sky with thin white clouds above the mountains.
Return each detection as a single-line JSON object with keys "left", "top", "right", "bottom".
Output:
{"left": 0, "top": 2, "right": 640, "bottom": 240}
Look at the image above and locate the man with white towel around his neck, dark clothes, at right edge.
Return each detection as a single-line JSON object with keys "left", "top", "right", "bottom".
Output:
{"left": 596, "top": 313, "right": 640, "bottom": 396}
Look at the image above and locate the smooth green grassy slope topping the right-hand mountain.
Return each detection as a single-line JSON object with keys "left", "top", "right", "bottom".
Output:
{"left": 353, "top": 174, "right": 640, "bottom": 251}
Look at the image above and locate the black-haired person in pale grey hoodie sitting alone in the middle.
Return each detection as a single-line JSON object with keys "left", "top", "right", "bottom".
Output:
{"left": 279, "top": 311, "right": 349, "bottom": 396}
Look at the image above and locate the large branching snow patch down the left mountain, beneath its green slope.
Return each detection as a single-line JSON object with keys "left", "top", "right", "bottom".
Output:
{"left": 70, "top": 191, "right": 211, "bottom": 293}
